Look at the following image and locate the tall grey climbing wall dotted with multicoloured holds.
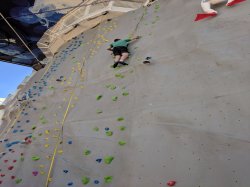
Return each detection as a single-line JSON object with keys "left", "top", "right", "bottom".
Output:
{"left": 0, "top": 0, "right": 250, "bottom": 187}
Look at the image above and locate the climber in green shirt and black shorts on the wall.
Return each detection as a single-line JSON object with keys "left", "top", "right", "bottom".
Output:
{"left": 107, "top": 36, "right": 140, "bottom": 68}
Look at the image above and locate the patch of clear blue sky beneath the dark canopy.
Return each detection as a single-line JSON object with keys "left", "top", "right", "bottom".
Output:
{"left": 0, "top": 61, "right": 33, "bottom": 98}
